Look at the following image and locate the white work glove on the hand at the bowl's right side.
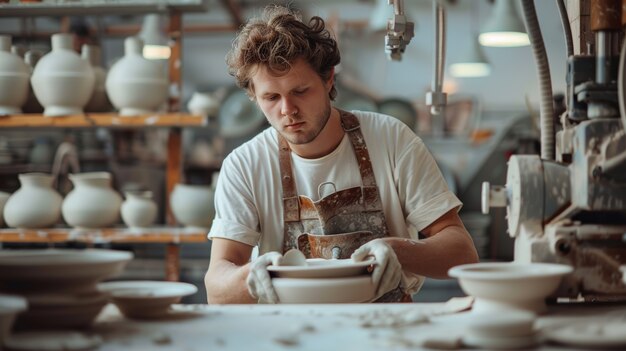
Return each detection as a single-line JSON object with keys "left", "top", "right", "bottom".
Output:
{"left": 351, "top": 239, "right": 402, "bottom": 300}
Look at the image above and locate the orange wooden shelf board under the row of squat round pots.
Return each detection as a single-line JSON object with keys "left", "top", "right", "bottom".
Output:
{"left": 0, "top": 227, "right": 208, "bottom": 244}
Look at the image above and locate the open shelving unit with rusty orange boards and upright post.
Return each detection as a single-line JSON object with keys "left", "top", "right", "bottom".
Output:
{"left": 0, "top": 0, "right": 214, "bottom": 281}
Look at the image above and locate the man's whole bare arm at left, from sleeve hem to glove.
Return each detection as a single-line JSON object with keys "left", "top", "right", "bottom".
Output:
{"left": 204, "top": 238, "right": 257, "bottom": 304}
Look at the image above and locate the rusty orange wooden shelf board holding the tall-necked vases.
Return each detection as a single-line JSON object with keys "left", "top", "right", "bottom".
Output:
{"left": 0, "top": 113, "right": 208, "bottom": 128}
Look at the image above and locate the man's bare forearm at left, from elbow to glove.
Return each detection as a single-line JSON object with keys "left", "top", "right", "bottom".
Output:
{"left": 204, "top": 260, "right": 257, "bottom": 304}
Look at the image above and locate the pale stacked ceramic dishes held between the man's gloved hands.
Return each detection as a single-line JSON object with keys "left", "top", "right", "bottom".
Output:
{"left": 268, "top": 259, "right": 375, "bottom": 303}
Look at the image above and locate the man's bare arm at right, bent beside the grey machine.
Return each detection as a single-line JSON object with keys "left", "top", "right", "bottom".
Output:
{"left": 383, "top": 209, "right": 478, "bottom": 279}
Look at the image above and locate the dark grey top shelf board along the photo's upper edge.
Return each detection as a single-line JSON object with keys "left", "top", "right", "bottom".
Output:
{"left": 0, "top": 0, "right": 208, "bottom": 17}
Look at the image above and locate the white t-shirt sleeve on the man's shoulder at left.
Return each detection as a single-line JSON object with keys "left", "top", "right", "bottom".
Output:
{"left": 208, "top": 154, "right": 260, "bottom": 246}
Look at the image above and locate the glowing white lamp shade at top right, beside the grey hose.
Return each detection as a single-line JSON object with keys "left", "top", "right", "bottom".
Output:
{"left": 478, "top": 0, "right": 530, "bottom": 47}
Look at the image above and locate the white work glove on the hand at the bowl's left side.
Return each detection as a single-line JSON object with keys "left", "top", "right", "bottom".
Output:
{"left": 246, "top": 251, "right": 283, "bottom": 303}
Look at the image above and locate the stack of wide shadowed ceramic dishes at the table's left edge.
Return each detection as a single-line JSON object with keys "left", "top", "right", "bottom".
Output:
{"left": 0, "top": 249, "right": 133, "bottom": 329}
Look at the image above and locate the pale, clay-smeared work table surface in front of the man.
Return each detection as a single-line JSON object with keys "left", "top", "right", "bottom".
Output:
{"left": 86, "top": 303, "right": 626, "bottom": 351}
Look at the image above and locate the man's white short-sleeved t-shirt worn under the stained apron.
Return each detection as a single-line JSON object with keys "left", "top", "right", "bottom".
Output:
{"left": 209, "top": 111, "right": 461, "bottom": 293}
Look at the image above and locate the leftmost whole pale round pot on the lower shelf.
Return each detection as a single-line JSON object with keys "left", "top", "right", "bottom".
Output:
{"left": 4, "top": 173, "right": 63, "bottom": 228}
